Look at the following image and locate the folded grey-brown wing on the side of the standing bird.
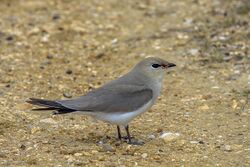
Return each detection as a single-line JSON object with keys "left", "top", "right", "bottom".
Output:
{"left": 56, "top": 85, "right": 153, "bottom": 113}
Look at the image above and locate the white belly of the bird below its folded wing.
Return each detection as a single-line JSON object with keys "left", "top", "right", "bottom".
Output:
{"left": 91, "top": 100, "right": 153, "bottom": 126}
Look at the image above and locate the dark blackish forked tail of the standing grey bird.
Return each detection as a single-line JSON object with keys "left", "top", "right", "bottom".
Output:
{"left": 26, "top": 98, "right": 76, "bottom": 114}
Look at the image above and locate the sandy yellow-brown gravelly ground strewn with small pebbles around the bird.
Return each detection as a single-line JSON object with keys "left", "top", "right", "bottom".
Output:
{"left": 0, "top": 0, "right": 250, "bottom": 167}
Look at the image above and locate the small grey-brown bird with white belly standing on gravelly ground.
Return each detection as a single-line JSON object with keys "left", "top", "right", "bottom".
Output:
{"left": 26, "top": 57, "right": 176, "bottom": 144}
